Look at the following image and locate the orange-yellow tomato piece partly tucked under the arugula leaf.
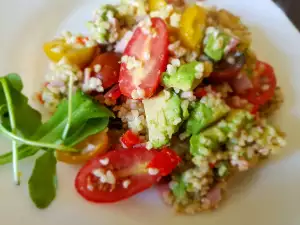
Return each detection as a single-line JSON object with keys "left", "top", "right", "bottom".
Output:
{"left": 56, "top": 131, "right": 109, "bottom": 164}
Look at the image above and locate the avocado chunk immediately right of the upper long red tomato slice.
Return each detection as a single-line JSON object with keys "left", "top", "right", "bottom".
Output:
{"left": 162, "top": 61, "right": 205, "bottom": 91}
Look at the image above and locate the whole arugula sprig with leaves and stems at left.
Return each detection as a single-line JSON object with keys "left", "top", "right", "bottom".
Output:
{"left": 0, "top": 74, "right": 114, "bottom": 208}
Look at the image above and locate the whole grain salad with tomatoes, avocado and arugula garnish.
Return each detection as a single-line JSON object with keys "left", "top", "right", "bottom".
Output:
{"left": 0, "top": 0, "right": 285, "bottom": 214}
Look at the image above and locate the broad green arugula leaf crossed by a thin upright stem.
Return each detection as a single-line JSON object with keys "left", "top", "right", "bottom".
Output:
{"left": 0, "top": 91, "right": 114, "bottom": 165}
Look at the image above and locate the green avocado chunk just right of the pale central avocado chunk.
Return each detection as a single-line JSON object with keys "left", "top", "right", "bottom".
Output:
{"left": 186, "top": 94, "right": 230, "bottom": 135}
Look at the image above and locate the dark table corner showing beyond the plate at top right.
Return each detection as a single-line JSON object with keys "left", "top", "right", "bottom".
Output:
{"left": 274, "top": 0, "right": 300, "bottom": 30}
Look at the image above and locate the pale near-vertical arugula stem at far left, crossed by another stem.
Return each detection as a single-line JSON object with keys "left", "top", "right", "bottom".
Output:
{"left": 0, "top": 78, "right": 20, "bottom": 185}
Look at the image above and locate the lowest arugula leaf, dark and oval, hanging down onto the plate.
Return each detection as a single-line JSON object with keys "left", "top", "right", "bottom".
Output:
{"left": 28, "top": 152, "right": 57, "bottom": 209}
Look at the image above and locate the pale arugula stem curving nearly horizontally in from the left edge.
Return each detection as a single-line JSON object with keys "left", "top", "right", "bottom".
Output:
{"left": 0, "top": 124, "right": 78, "bottom": 152}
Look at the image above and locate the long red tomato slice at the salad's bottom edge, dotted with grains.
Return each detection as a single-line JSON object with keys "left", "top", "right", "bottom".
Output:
{"left": 75, "top": 147, "right": 181, "bottom": 203}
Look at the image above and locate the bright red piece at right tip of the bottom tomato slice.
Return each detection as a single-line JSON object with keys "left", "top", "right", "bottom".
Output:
{"left": 148, "top": 148, "right": 181, "bottom": 176}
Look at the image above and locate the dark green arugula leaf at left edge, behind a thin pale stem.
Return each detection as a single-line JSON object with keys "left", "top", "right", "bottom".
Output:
{"left": 0, "top": 74, "right": 41, "bottom": 137}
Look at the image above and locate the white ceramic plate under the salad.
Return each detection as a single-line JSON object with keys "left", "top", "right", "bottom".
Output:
{"left": 0, "top": 0, "right": 300, "bottom": 225}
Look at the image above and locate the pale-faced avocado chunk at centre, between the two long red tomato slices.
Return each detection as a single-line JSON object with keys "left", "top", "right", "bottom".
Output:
{"left": 143, "top": 90, "right": 183, "bottom": 148}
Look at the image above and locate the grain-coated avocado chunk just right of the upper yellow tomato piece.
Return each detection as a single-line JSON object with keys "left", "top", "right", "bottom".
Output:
{"left": 204, "top": 27, "right": 232, "bottom": 61}
